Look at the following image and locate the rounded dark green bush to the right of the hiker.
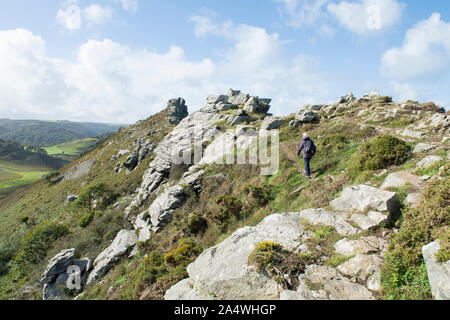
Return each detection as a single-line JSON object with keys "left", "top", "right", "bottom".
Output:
{"left": 349, "top": 135, "right": 411, "bottom": 177}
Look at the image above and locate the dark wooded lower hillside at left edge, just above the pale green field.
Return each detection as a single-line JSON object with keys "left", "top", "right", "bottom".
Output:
{"left": 0, "top": 139, "right": 68, "bottom": 169}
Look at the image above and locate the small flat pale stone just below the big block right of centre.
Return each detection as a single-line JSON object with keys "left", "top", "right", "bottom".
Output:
{"left": 334, "top": 236, "right": 387, "bottom": 256}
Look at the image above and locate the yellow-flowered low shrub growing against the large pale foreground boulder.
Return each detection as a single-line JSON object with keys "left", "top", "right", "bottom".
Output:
{"left": 248, "top": 241, "right": 314, "bottom": 290}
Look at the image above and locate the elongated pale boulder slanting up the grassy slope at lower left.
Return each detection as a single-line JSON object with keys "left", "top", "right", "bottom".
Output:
{"left": 87, "top": 230, "right": 138, "bottom": 284}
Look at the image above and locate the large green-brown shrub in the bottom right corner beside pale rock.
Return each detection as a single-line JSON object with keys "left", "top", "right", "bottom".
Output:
{"left": 381, "top": 177, "right": 450, "bottom": 299}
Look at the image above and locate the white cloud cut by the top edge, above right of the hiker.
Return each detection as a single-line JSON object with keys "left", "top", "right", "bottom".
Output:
{"left": 327, "top": 0, "right": 405, "bottom": 35}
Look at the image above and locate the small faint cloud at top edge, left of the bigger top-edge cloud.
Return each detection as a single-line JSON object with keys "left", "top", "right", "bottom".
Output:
{"left": 275, "top": 0, "right": 330, "bottom": 28}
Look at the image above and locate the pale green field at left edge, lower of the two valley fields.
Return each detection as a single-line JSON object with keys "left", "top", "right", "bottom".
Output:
{"left": 0, "top": 162, "right": 48, "bottom": 189}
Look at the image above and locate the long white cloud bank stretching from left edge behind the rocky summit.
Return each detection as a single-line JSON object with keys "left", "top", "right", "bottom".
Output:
{"left": 0, "top": 25, "right": 329, "bottom": 122}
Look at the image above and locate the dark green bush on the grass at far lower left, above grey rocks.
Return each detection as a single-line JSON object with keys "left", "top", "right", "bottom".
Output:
{"left": 15, "top": 222, "right": 70, "bottom": 271}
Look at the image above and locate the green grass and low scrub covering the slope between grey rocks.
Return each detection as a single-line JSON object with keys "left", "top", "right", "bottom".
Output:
{"left": 0, "top": 104, "right": 448, "bottom": 299}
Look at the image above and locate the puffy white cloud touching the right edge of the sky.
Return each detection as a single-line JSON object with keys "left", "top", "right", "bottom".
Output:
{"left": 381, "top": 13, "right": 450, "bottom": 80}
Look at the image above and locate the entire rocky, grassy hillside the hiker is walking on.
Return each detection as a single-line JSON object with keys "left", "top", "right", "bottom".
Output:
{"left": 0, "top": 90, "right": 450, "bottom": 300}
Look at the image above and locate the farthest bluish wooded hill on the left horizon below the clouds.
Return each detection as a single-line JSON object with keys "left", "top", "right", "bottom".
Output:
{"left": 0, "top": 119, "right": 126, "bottom": 146}
